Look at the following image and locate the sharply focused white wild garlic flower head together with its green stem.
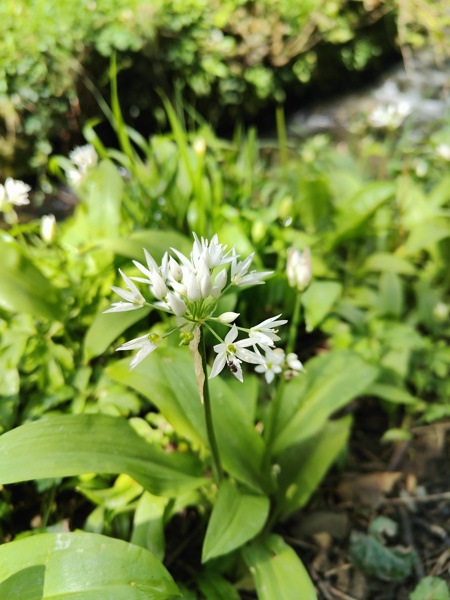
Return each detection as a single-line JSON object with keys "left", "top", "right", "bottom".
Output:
{"left": 105, "top": 233, "right": 302, "bottom": 482}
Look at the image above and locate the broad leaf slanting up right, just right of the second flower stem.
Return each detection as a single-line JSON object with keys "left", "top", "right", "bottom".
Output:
{"left": 273, "top": 350, "right": 378, "bottom": 454}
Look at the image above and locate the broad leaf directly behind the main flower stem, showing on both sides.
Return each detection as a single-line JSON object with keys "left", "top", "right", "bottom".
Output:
{"left": 108, "top": 347, "right": 264, "bottom": 490}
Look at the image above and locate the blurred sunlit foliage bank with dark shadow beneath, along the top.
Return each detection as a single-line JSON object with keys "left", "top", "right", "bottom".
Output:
{"left": 0, "top": 0, "right": 450, "bottom": 177}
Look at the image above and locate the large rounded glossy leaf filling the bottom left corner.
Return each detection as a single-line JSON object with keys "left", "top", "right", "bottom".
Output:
{"left": 0, "top": 533, "right": 181, "bottom": 600}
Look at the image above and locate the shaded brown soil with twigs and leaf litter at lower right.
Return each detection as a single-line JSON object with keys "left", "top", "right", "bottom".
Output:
{"left": 280, "top": 405, "right": 450, "bottom": 600}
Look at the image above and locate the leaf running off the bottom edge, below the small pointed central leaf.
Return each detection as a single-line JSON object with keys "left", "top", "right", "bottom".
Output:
{"left": 242, "top": 535, "right": 317, "bottom": 600}
